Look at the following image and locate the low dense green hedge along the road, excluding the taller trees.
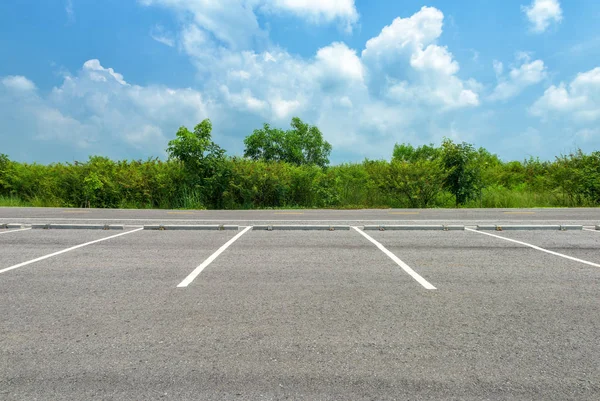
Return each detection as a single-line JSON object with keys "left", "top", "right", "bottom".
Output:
{"left": 0, "top": 147, "right": 600, "bottom": 209}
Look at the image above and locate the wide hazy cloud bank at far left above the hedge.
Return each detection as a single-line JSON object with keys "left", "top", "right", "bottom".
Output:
{"left": 0, "top": 60, "right": 209, "bottom": 157}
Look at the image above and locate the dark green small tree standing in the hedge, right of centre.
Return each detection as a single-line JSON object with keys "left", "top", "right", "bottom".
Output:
{"left": 442, "top": 138, "right": 481, "bottom": 206}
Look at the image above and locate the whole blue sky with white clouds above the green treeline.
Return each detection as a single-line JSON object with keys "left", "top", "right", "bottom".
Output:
{"left": 0, "top": 0, "right": 600, "bottom": 163}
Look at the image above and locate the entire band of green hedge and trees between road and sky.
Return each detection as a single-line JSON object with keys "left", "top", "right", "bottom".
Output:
{"left": 0, "top": 118, "right": 600, "bottom": 209}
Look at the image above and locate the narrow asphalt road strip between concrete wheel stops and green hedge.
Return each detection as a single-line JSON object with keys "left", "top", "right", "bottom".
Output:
{"left": 0, "top": 208, "right": 600, "bottom": 226}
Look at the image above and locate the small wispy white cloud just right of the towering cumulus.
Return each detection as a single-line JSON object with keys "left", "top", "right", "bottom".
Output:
{"left": 490, "top": 53, "right": 548, "bottom": 100}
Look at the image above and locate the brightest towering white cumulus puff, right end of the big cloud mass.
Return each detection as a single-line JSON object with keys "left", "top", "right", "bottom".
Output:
{"left": 362, "top": 7, "right": 479, "bottom": 109}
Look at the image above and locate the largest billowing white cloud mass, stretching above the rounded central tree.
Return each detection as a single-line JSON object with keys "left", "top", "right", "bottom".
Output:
{"left": 136, "top": 0, "right": 481, "bottom": 157}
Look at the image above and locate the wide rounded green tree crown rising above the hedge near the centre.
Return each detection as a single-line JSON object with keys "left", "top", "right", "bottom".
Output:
{"left": 244, "top": 117, "right": 331, "bottom": 167}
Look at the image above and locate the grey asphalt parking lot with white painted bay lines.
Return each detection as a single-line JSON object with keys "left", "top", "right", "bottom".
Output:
{"left": 0, "top": 209, "right": 600, "bottom": 400}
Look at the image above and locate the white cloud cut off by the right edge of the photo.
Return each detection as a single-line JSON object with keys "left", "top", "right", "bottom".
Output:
{"left": 530, "top": 67, "right": 600, "bottom": 124}
